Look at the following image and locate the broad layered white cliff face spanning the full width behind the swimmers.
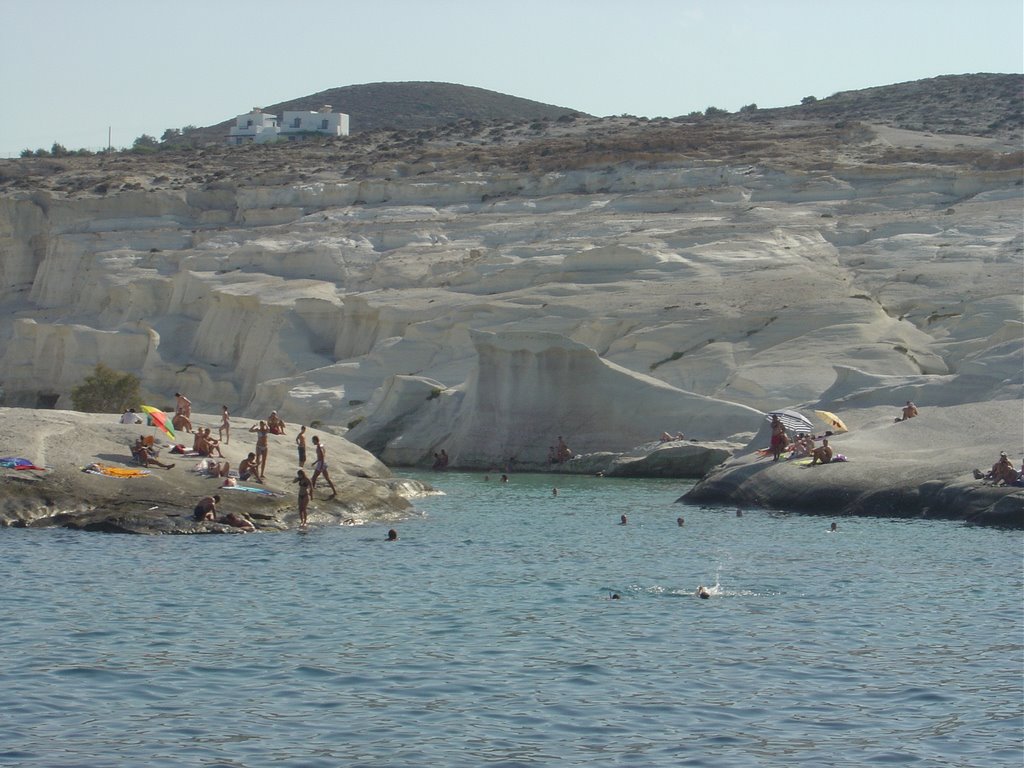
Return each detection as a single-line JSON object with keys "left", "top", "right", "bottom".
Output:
{"left": 0, "top": 118, "right": 1024, "bottom": 462}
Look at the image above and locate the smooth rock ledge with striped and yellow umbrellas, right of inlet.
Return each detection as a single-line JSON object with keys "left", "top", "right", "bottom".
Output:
{"left": 680, "top": 401, "right": 1024, "bottom": 528}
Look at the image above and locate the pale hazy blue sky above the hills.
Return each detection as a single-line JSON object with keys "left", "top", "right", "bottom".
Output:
{"left": 0, "top": 0, "right": 1024, "bottom": 158}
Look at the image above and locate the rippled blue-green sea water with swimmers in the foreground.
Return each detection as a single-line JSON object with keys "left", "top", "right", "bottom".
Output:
{"left": 0, "top": 473, "right": 1024, "bottom": 768}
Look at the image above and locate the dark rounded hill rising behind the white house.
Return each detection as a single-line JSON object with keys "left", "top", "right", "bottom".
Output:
{"left": 201, "top": 82, "right": 585, "bottom": 138}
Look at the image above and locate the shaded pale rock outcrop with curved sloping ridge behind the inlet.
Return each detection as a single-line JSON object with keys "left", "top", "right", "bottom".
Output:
{"left": 348, "top": 331, "right": 763, "bottom": 469}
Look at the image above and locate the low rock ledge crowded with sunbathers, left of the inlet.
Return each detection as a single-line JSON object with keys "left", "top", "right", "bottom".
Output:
{"left": 0, "top": 408, "right": 429, "bottom": 534}
